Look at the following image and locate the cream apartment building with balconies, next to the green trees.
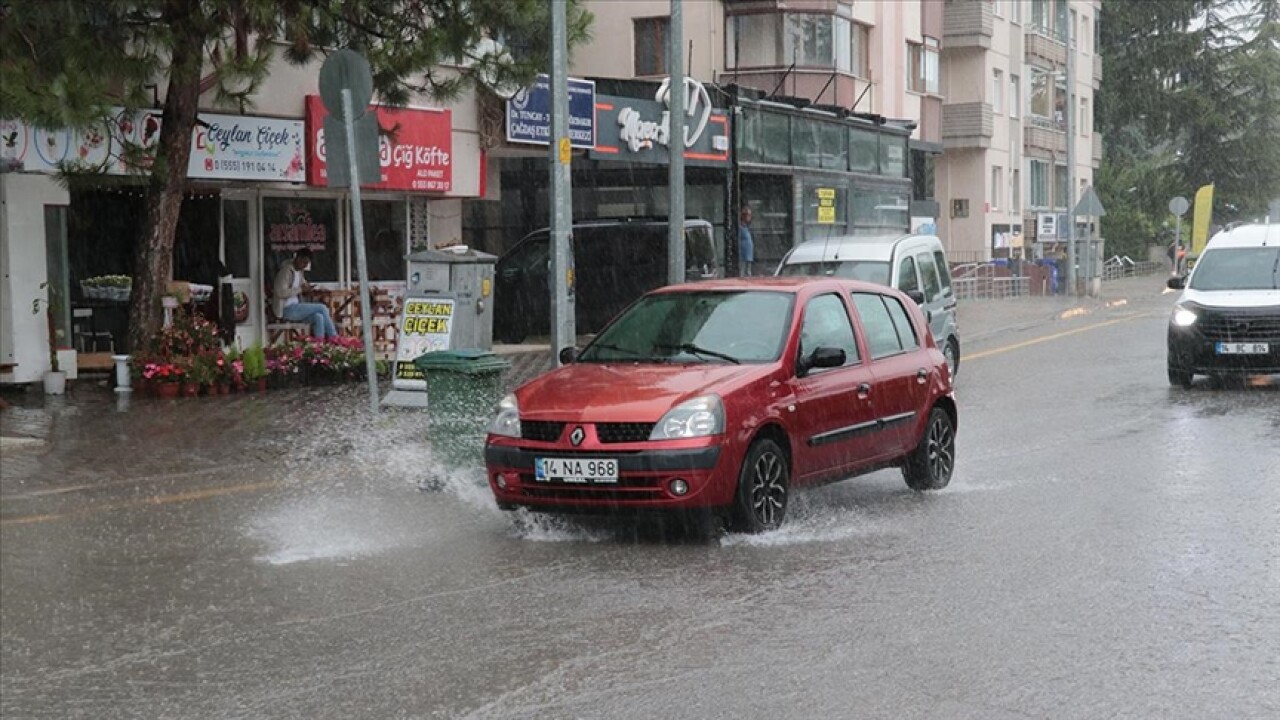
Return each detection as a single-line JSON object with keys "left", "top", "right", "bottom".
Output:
{"left": 936, "top": 0, "right": 1102, "bottom": 260}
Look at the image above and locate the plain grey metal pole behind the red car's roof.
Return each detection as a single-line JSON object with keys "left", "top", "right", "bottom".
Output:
{"left": 667, "top": 0, "right": 685, "bottom": 284}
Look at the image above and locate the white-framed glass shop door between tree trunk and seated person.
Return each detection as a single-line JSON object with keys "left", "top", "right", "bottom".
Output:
{"left": 221, "top": 191, "right": 265, "bottom": 348}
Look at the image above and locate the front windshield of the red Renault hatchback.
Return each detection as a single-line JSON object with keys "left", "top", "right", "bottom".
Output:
{"left": 579, "top": 291, "right": 792, "bottom": 364}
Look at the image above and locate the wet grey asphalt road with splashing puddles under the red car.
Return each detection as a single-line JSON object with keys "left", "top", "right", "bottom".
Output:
{"left": 0, "top": 283, "right": 1280, "bottom": 720}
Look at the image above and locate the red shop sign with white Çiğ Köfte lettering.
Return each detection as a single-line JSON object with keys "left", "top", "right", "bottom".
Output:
{"left": 307, "top": 95, "right": 453, "bottom": 192}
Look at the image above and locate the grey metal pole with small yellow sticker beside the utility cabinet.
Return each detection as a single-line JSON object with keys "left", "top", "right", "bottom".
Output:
{"left": 548, "top": 0, "right": 577, "bottom": 366}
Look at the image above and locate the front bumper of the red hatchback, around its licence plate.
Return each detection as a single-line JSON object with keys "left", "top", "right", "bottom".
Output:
{"left": 484, "top": 437, "right": 737, "bottom": 514}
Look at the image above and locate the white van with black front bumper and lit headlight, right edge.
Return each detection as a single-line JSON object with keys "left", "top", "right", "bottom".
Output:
{"left": 1169, "top": 223, "right": 1280, "bottom": 387}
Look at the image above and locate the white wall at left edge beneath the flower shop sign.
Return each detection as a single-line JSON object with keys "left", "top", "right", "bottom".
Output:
{"left": 0, "top": 174, "right": 70, "bottom": 383}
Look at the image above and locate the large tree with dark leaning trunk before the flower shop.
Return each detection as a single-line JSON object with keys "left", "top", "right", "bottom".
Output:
{"left": 0, "top": 0, "right": 591, "bottom": 347}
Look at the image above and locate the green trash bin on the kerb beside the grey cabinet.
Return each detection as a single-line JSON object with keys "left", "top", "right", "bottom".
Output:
{"left": 413, "top": 350, "right": 511, "bottom": 468}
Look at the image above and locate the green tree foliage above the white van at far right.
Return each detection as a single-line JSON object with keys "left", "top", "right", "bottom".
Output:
{"left": 1096, "top": 0, "right": 1280, "bottom": 255}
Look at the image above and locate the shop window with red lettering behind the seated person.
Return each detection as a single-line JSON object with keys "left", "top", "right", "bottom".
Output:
{"left": 262, "top": 197, "right": 342, "bottom": 282}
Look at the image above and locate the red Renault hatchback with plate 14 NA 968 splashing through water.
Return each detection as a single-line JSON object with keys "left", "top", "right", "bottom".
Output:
{"left": 485, "top": 278, "right": 956, "bottom": 532}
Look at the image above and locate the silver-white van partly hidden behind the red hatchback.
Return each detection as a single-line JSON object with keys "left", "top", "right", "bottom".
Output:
{"left": 776, "top": 234, "right": 960, "bottom": 378}
